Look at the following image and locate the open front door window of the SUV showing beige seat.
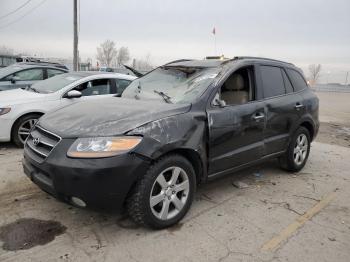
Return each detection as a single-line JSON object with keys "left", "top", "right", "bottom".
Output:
{"left": 214, "top": 67, "right": 255, "bottom": 105}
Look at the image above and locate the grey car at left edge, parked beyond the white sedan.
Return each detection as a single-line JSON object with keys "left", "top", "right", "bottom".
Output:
{"left": 0, "top": 62, "right": 68, "bottom": 91}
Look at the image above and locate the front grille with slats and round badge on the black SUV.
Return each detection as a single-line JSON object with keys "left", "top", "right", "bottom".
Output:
{"left": 26, "top": 126, "right": 61, "bottom": 163}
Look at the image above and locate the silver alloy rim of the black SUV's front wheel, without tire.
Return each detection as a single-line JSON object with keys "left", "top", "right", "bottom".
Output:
{"left": 149, "top": 167, "right": 190, "bottom": 220}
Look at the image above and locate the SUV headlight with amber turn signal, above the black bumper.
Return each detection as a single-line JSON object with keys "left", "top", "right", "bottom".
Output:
{"left": 67, "top": 136, "right": 142, "bottom": 158}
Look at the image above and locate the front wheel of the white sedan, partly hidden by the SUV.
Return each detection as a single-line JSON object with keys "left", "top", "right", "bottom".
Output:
{"left": 11, "top": 114, "right": 41, "bottom": 147}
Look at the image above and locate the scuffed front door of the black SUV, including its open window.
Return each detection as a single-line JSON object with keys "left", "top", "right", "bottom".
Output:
{"left": 207, "top": 66, "right": 266, "bottom": 176}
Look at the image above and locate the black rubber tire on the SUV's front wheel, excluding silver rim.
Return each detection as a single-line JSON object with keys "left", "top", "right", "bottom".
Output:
{"left": 126, "top": 154, "right": 196, "bottom": 229}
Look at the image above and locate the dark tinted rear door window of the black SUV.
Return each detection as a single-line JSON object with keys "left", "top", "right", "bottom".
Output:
{"left": 260, "top": 66, "right": 286, "bottom": 98}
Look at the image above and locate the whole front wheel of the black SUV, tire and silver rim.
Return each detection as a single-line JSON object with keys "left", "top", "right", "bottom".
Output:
{"left": 126, "top": 154, "right": 196, "bottom": 229}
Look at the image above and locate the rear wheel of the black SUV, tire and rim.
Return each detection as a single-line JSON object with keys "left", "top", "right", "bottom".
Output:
{"left": 279, "top": 126, "right": 311, "bottom": 172}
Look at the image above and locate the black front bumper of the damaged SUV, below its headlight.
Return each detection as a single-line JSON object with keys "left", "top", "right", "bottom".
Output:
{"left": 23, "top": 139, "right": 149, "bottom": 210}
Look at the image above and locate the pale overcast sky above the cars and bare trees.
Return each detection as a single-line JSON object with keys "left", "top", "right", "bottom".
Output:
{"left": 0, "top": 0, "right": 350, "bottom": 83}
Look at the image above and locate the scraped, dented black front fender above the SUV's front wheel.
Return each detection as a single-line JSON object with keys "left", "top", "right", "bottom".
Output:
{"left": 127, "top": 113, "right": 207, "bottom": 182}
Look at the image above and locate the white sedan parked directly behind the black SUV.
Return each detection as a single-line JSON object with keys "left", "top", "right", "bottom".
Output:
{"left": 0, "top": 72, "right": 136, "bottom": 146}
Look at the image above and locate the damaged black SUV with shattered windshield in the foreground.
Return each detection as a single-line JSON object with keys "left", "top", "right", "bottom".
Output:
{"left": 23, "top": 57, "right": 319, "bottom": 228}
